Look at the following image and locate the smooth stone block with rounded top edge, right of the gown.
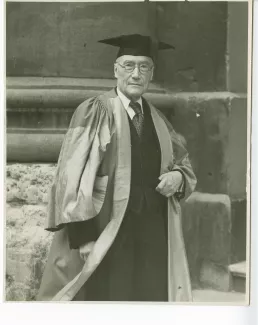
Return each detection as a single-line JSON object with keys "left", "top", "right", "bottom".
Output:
{"left": 182, "top": 192, "right": 233, "bottom": 291}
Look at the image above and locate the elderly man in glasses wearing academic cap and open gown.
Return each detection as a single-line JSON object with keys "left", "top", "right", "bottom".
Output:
{"left": 38, "top": 35, "right": 196, "bottom": 301}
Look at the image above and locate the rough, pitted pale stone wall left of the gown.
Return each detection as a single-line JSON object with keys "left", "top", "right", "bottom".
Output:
{"left": 6, "top": 164, "right": 55, "bottom": 301}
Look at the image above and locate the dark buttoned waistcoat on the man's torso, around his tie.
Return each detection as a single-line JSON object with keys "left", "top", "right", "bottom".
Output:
{"left": 128, "top": 100, "right": 165, "bottom": 212}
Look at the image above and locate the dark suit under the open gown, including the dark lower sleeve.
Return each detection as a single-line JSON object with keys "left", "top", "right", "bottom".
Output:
{"left": 71, "top": 100, "right": 169, "bottom": 301}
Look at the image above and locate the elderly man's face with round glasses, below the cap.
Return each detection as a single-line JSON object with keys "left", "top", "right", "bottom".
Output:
{"left": 114, "top": 55, "right": 153, "bottom": 101}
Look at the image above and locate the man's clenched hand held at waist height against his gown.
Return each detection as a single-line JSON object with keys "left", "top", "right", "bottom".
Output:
{"left": 156, "top": 170, "right": 183, "bottom": 197}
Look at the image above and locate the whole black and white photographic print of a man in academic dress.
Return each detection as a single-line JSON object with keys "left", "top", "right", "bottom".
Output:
{"left": 4, "top": 0, "right": 252, "bottom": 306}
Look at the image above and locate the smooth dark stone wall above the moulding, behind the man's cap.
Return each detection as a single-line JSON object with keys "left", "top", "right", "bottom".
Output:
{"left": 6, "top": 1, "right": 227, "bottom": 91}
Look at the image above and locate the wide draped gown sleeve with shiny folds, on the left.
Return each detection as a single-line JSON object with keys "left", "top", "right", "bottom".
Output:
{"left": 45, "top": 97, "right": 113, "bottom": 230}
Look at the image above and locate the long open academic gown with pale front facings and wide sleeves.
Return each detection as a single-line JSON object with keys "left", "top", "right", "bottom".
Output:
{"left": 38, "top": 90, "right": 196, "bottom": 301}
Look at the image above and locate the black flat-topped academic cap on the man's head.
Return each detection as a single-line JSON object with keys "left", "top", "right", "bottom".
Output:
{"left": 99, "top": 34, "right": 174, "bottom": 58}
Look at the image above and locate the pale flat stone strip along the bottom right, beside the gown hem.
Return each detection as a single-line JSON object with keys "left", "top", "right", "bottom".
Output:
{"left": 193, "top": 289, "right": 248, "bottom": 305}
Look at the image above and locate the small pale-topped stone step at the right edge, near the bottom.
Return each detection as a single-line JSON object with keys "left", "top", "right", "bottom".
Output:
{"left": 229, "top": 261, "right": 247, "bottom": 293}
